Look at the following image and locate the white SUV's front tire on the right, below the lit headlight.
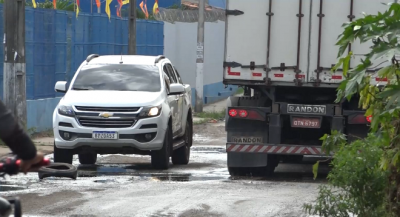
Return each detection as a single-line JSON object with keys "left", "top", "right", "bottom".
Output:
{"left": 151, "top": 124, "right": 172, "bottom": 170}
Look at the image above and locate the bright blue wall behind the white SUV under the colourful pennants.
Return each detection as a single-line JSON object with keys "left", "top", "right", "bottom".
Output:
{"left": 0, "top": 4, "right": 164, "bottom": 131}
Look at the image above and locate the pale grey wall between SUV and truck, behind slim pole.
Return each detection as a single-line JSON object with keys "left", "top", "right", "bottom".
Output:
{"left": 164, "top": 21, "right": 237, "bottom": 104}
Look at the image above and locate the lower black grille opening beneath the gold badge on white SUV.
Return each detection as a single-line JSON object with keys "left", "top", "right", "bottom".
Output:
{"left": 78, "top": 117, "right": 135, "bottom": 128}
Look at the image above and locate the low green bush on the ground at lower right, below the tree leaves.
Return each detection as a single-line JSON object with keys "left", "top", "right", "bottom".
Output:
{"left": 304, "top": 133, "right": 390, "bottom": 217}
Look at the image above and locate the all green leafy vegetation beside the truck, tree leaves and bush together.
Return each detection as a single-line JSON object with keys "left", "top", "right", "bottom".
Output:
{"left": 304, "top": 3, "right": 400, "bottom": 217}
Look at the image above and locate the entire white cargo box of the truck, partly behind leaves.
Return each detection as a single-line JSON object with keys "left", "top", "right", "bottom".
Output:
{"left": 224, "top": 0, "right": 389, "bottom": 87}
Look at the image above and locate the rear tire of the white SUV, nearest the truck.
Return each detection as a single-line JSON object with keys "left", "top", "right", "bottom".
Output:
{"left": 172, "top": 120, "right": 192, "bottom": 165}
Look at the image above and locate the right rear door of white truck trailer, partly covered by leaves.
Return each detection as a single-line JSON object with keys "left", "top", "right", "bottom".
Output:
{"left": 308, "top": 0, "right": 388, "bottom": 84}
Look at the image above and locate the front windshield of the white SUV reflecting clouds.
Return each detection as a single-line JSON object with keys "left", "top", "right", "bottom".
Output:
{"left": 72, "top": 64, "right": 161, "bottom": 92}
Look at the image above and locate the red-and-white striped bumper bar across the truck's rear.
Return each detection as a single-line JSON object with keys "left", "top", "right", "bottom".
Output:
{"left": 226, "top": 144, "right": 325, "bottom": 155}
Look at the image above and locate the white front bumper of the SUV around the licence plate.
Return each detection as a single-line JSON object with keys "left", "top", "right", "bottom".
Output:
{"left": 53, "top": 112, "right": 168, "bottom": 151}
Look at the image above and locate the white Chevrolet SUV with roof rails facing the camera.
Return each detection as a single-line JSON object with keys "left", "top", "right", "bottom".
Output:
{"left": 53, "top": 54, "right": 193, "bottom": 169}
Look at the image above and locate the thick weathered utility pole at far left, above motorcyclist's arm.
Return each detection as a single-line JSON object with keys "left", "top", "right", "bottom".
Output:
{"left": 3, "top": 0, "right": 27, "bottom": 127}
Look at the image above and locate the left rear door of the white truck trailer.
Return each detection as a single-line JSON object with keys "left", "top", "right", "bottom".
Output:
{"left": 224, "top": 0, "right": 311, "bottom": 82}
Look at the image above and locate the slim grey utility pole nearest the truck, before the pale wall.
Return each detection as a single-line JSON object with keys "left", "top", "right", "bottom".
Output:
{"left": 194, "top": 0, "right": 206, "bottom": 112}
